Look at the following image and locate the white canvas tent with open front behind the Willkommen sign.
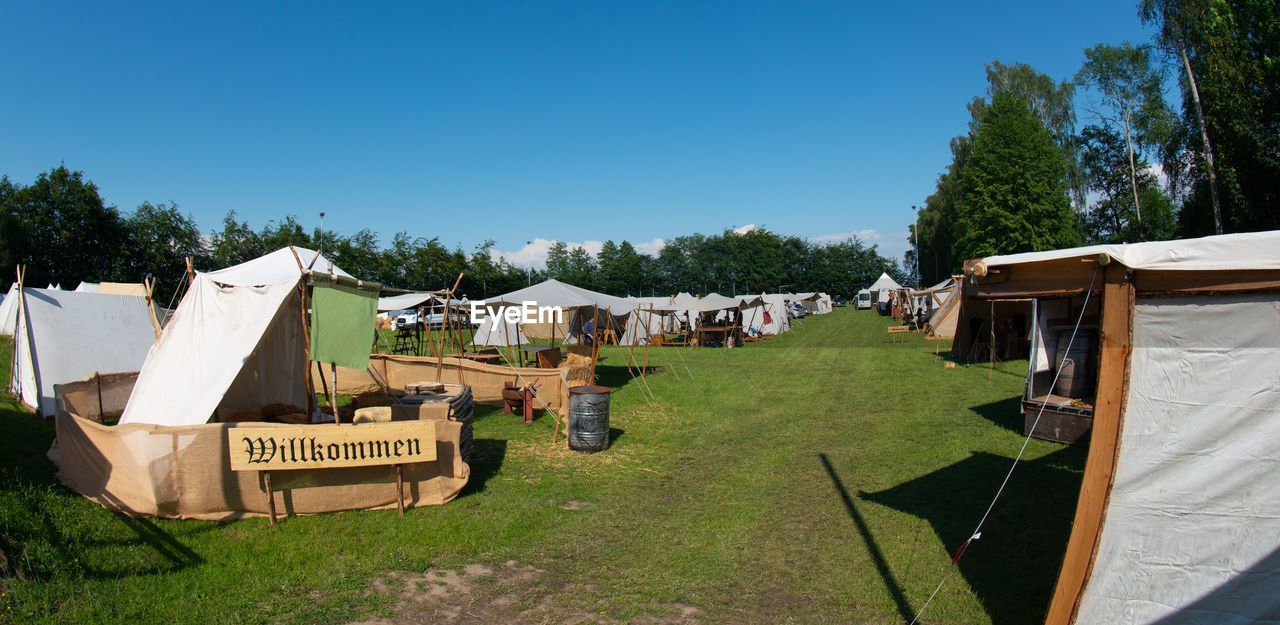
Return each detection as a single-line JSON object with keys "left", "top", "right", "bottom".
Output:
{"left": 120, "top": 247, "right": 351, "bottom": 425}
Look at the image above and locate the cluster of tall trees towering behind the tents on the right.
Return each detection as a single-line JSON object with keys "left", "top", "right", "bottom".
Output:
{"left": 905, "top": 0, "right": 1280, "bottom": 284}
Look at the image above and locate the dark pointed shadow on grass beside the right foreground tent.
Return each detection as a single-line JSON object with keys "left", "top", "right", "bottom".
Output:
{"left": 859, "top": 447, "right": 1085, "bottom": 625}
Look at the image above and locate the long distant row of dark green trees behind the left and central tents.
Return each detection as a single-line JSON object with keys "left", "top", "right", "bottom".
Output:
{"left": 0, "top": 165, "right": 902, "bottom": 304}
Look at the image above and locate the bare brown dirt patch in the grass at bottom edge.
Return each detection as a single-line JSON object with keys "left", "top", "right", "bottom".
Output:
{"left": 351, "top": 561, "right": 701, "bottom": 625}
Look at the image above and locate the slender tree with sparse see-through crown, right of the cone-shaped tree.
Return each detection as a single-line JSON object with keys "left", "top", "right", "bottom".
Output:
{"left": 1075, "top": 41, "right": 1174, "bottom": 238}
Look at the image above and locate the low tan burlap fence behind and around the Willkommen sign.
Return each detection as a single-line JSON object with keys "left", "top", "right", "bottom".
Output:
{"left": 49, "top": 374, "right": 471, "bottom": 520}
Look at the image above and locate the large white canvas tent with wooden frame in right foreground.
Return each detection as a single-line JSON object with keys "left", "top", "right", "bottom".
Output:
{"left": 961, "top": 232, "right": 1280, "bottom": 625}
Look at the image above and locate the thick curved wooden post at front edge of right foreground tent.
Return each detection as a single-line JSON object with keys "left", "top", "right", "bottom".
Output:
{"left": 1044, "top": 263, "right": 1134, "bottom": 625}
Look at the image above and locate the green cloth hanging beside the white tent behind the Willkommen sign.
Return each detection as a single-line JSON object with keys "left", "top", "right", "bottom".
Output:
{"left": 311, "top": 274, "right": 381, "bottom": 371}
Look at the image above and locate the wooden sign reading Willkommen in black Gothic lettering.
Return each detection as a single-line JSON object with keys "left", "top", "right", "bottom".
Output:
{"left": 227, "top": 421, "right": 435, "bottom": 471}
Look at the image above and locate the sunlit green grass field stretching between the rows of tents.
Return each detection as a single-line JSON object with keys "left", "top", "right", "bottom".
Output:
{"left": 0, "top": 309, "right": 1084, "bottom": 624}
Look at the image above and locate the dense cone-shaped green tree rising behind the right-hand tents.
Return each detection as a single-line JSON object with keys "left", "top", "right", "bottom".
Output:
{"left": 955, "top": 93, "right": 1080, "bottom": 259}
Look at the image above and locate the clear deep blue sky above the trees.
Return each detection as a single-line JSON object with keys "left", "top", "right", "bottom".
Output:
{"left": 0, "top": 0, "right": 1149, "bottom": 267}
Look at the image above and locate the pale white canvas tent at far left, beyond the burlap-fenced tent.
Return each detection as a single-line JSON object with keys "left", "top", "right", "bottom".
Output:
{"left": 6, "top": 288, "right": 156, "bottom": 416}
